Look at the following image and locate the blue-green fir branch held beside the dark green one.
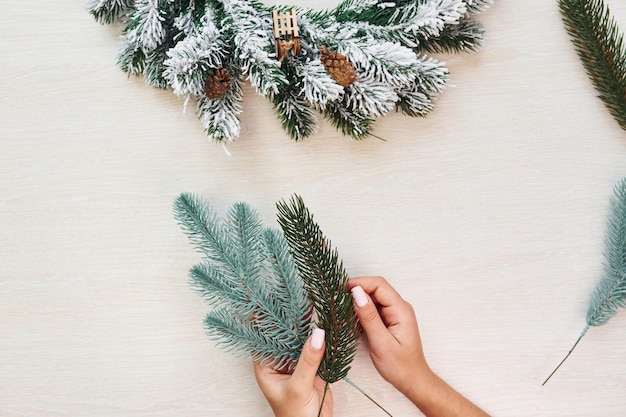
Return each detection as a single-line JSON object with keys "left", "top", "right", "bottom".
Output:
{"left": 174, "top": 193, "right": 312, "bottom": 372}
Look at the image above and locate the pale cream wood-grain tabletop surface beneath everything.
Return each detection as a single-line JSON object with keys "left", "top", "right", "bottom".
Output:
{"left": 0, "top": 0, "right": 626, "bottom": 417}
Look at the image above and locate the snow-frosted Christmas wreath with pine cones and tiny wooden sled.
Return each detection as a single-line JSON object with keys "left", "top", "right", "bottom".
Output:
{"left": 87, "top": 0, "right": 493, "bottom": 142}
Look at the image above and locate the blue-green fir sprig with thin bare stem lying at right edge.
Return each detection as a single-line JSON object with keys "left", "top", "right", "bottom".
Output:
{"left": 542, "top": 178, "right": 626, "bottom": 385}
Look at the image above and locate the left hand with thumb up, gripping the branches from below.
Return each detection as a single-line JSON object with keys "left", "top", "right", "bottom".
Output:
{"left": 254, "top": 329, "right": 333, "bottom": 417}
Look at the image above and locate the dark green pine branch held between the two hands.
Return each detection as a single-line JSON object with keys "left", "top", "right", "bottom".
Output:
{"left": 277, "top": 196, "right": 359, "bottom": 383}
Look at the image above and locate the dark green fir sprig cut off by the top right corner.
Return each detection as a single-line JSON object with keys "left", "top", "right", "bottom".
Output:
{"left": 559, "top": 0, "right": 626, "bottom": 130}
